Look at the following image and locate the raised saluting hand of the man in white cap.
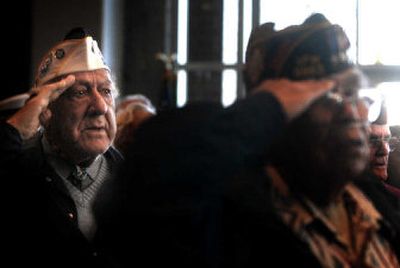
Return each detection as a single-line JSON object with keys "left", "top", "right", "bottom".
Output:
{"left": 7, "top": 75, "right": 75, "bottom": 140}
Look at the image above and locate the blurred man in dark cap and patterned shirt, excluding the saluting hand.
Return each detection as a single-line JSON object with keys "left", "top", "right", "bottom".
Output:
{"left": 230, "top": 14, "right": 400, "bottom": 267}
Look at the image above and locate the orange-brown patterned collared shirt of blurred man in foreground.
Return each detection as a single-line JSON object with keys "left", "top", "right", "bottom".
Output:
{"left": 267, "top": 167, "right": 400, "bottom": 268}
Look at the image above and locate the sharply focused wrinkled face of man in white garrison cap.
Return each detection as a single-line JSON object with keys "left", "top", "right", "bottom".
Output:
{"left": 46, "top": 69, "right": 116, "bottom": 164}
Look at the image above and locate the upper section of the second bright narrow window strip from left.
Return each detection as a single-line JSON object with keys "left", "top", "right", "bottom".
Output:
{"left": 222, "top": 0, "right": 239, "bottom": 64}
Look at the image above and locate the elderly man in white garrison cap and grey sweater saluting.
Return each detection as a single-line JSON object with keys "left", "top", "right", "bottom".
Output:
{"left": 0, "top": 28, "right": 122, "bottom": 267}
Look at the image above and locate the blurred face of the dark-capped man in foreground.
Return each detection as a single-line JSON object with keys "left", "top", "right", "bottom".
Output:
{"left": 310, "top": 97, "right": 369, "bottom": 179}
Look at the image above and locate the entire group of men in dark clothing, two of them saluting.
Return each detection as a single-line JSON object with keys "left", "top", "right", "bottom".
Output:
{"left": 0, "top": 14, "right": 400, "bottom": 268}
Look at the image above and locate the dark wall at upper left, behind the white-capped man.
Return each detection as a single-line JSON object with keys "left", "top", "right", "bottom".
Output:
{"left": 0, "top": 0, "right": 103, "bottom": 99}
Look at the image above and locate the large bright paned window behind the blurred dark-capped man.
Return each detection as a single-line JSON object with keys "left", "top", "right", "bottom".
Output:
{"left": 177, "top": 0, "right": 400, "bottom": 114}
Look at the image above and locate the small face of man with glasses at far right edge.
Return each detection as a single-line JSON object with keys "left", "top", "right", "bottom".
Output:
{"left": 369, "top": 124, "right": 391, "bottom": 180}
